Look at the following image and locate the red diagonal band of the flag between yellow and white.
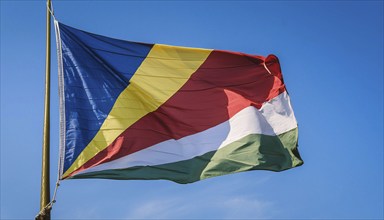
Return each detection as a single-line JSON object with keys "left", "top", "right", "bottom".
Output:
{"left": 70, "top": 50, "right": 285, "bottom": 176}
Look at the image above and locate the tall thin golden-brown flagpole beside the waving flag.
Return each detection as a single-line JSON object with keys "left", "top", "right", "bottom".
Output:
{"left": 39, "top": 0, "right": 51, "bottom": 220}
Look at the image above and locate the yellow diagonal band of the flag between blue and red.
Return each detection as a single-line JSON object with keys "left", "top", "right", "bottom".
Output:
{"left": 63, "top": 44, "right": 212, "bottom": 178}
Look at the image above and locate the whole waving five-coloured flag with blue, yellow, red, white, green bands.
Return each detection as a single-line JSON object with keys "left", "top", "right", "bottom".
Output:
{"left": 55, "top": 21, "right": 303, "bottom": 183}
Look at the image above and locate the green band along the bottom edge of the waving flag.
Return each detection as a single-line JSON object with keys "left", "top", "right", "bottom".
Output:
{"left": 72, "top": 128, "right": 303, "bottom": 183}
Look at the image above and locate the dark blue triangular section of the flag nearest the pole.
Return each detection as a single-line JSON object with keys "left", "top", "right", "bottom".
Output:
{"left": 59, "top": 23, "right": 153, "bottom": 172}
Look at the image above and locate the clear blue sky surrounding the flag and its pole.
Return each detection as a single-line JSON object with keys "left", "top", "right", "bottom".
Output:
{"left": 0, "top": 0, "right": 384, "bottom": 219}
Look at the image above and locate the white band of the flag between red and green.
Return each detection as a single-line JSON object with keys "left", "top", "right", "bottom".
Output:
{"left": 78, "top": 92, "right": 297, "bottom": 174}
